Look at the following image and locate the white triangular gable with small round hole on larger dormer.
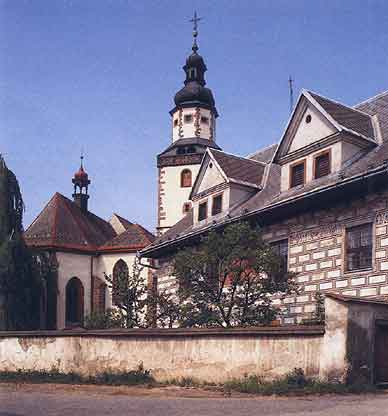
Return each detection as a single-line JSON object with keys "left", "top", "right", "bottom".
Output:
{"left": 289, "top": 104, "right": 336, "bottom": 152}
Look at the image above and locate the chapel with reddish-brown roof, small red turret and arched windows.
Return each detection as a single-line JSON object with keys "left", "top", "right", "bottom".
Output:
{"left": 24, "top": 157, "right": 154, "bottom": 329}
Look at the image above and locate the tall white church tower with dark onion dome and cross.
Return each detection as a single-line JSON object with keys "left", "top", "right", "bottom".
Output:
{"left": 157, "top": 13, "right": 220, "bottom": 235}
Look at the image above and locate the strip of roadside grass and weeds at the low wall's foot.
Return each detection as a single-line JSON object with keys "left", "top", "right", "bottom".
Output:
{"left": 0, "top": 363, "right": 379, "bottom": 396}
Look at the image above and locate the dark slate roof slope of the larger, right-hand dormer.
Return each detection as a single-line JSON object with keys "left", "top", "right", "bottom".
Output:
{"left": 308, "top": 91, "right": 374, "bottom": 139}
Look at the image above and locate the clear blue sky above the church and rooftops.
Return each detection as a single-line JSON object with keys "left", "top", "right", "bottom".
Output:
{"left": 0, "top": 0, "right": 388, "bottom": 229}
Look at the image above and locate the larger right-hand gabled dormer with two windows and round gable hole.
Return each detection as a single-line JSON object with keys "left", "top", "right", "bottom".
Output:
{"left": 274, "top": 90, "right": 377, "bottom": 191}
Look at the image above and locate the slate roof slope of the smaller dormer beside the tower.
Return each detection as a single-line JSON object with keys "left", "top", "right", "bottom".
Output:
{"left": 210, "top": 149, "right": 265, "bottom": 186}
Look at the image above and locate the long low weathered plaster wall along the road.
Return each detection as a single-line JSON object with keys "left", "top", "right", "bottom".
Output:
{"left": 0, "top": 327, "right": 323, "bottom": 382}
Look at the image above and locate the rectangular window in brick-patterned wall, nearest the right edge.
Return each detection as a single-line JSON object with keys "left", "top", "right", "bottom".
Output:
{"left": 346, "top": 223, "right": 373, "bottom": 271}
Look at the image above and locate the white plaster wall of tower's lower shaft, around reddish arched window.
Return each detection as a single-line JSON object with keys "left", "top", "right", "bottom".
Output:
{"left": 159, "top": 165, "right": 200, "bottom": 227}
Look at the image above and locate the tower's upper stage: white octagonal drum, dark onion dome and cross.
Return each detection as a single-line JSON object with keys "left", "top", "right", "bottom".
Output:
{"left": 170, "top": 13, "right": 218, "bottom": 142}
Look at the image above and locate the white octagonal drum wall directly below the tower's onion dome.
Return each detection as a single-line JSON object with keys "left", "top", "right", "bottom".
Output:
{"left": 171, "top": 107, "right": 216, "bottom": 142}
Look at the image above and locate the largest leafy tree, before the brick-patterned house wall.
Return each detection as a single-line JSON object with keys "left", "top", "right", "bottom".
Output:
{"left": 174, "top": 222, "right": 296, "bottom": 327}
